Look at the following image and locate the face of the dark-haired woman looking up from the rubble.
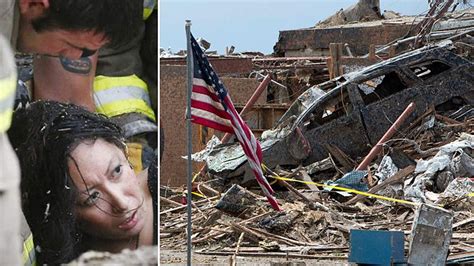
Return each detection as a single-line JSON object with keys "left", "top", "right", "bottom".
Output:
{"left": 68, "top": 139, "right": 147, "bottom": 240}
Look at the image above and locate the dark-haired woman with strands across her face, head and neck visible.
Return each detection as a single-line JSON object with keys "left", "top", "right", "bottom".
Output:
{"left": 8, "top": 101, "right": 157, "bottom": 264}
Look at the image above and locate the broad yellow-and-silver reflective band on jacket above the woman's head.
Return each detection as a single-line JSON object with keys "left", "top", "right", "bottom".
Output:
{"left": 94, "top": 75, "right": 156, "bottom": 121}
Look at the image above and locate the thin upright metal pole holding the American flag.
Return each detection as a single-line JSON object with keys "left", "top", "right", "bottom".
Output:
{"left": 185, "top": 20, "right": 194, "bottom": 266}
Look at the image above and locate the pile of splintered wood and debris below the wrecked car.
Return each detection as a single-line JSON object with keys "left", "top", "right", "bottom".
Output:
{"left": 160, "top": 110, "right": 474, "bottom": 260}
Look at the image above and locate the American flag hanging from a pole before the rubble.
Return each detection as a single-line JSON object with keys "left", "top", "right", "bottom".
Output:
{"left": 187, "top": 35, "right": 280, "bottom": 210}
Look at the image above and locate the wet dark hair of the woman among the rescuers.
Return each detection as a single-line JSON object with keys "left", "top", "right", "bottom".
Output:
{"left": 8, "top": 101, "right": 126, "bottom": 264}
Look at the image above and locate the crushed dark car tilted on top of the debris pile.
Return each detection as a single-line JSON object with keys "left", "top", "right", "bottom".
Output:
{"left": 201, "top": 41, "right": 474, "bottom": 183}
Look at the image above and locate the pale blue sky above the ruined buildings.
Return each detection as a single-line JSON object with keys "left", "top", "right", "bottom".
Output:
{"left": 159, "top": 0, "right": 429, "bottom": 54}
